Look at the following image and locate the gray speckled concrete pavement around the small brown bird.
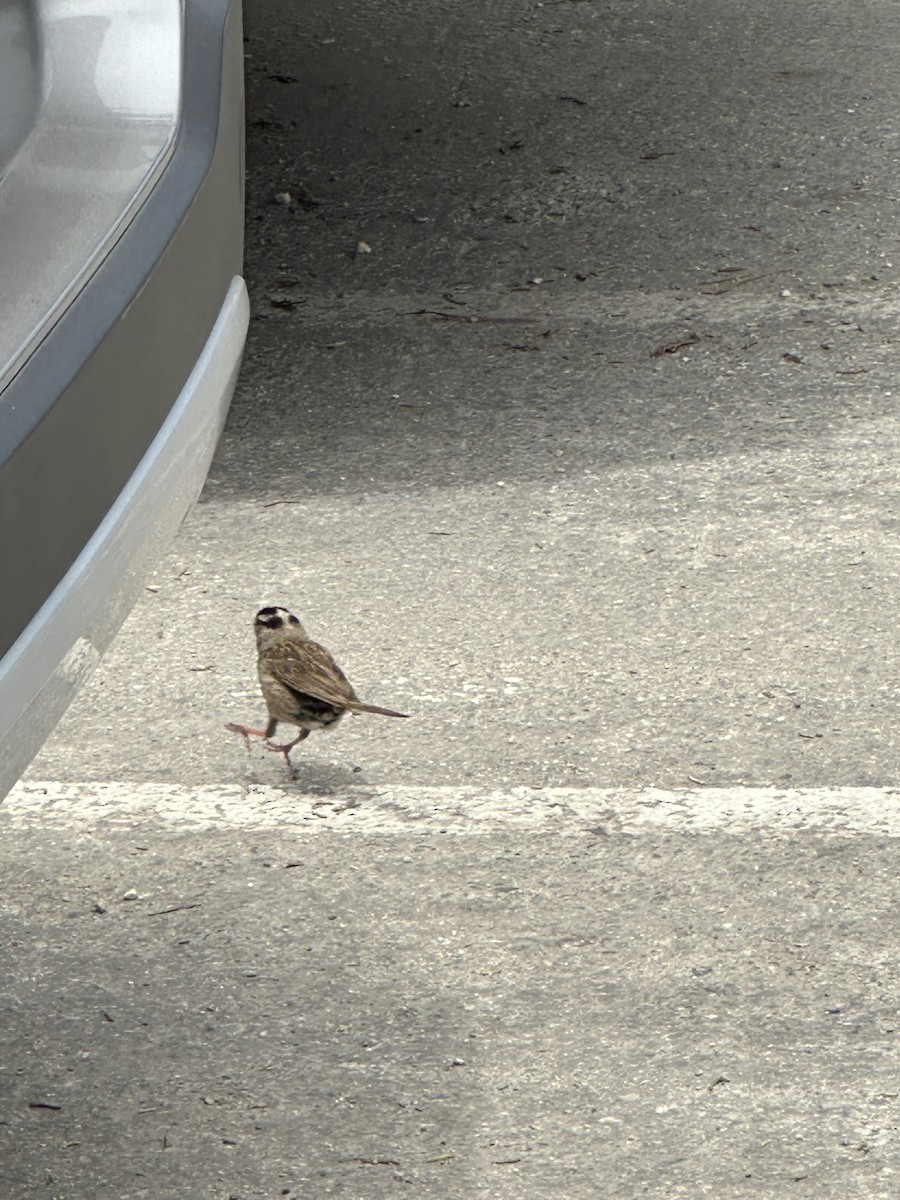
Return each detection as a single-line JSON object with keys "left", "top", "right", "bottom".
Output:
{"left": 0, "top": 0, "right": 900, "bottom": 1200}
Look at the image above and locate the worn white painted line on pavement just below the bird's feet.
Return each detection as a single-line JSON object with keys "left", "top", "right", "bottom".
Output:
{"left": 7, "top": 782, "right": 900, "bottom": 838}
